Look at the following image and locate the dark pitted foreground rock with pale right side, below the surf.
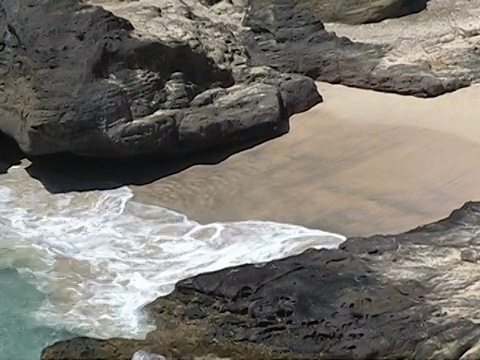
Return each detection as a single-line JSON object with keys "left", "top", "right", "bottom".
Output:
{"left": 42, "top": 202, "right": 480, "bottom": 360}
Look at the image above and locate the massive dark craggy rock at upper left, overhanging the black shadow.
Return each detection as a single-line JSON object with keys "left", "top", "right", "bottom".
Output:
{"left": 0, "top": 0, "right": 319, "bottom": 157}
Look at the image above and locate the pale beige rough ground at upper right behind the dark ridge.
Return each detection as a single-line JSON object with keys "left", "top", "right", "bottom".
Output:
{"left": 326, "top": 0, "right": 480, "bottom": 89}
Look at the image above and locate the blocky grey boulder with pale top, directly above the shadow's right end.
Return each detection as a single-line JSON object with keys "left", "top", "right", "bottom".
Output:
{"left": 177, "top": 85, "right": 288, "bottom": 153}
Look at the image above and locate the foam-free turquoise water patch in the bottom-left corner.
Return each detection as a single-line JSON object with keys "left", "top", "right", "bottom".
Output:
{"left": 0, "top": 269, "right": 71, "bottom": 360}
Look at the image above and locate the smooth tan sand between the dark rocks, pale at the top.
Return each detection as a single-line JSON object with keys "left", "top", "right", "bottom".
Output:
{"left": 131, "top": 83, "right": 480, "bottom": 236}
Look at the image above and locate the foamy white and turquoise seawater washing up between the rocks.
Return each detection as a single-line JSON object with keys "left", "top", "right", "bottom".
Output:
{"left": 0, "top": 168, "right": 344, "bottom": 360}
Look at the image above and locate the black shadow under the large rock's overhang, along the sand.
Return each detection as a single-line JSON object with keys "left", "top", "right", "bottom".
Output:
{"left": 0, "top": 129, "right": 288, "bottom": 193}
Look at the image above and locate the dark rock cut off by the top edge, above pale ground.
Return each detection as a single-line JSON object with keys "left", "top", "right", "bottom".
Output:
{"left": 288, "top": 0, "right": 428, "bottom": 24}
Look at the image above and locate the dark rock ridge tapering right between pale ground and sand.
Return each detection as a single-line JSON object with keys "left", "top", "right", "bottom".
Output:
{"left": 244, "top": 0, "right": 470, "bottom": 97}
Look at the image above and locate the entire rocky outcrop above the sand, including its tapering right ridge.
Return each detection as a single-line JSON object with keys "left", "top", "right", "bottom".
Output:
{"left": 0, "top": 0, "right": 476, "bottom": 158}
